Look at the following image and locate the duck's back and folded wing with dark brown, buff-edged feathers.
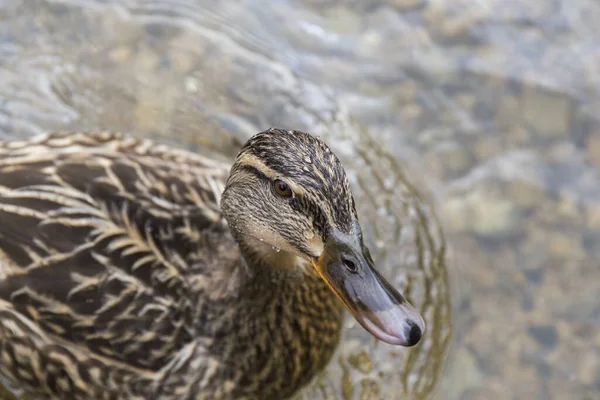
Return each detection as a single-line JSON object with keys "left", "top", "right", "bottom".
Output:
{"left": 0, "top": 132, "right": 228, "bottom": 376}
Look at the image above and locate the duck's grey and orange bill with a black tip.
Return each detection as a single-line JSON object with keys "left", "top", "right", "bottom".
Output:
{"left": 313, "top": 228, "right": 425, "bottom": 347}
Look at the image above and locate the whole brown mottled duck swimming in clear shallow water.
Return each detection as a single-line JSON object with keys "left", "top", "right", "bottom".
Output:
{"left": 0, "top": 128, "right": 425, "bottom": 400}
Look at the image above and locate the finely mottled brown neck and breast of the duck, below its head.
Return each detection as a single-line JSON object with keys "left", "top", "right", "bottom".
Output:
{"left": 221, "top": 239, "right": 343, "bottom": 398}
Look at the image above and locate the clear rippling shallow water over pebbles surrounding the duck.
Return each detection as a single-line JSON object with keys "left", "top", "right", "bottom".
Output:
{"left": 0, "top": 0, "right": 600, "bottom": 400}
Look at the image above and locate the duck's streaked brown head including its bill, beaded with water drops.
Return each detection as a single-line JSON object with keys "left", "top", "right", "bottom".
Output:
{"left": 221, "top": 129, "right": 425, "bottom": 346}
